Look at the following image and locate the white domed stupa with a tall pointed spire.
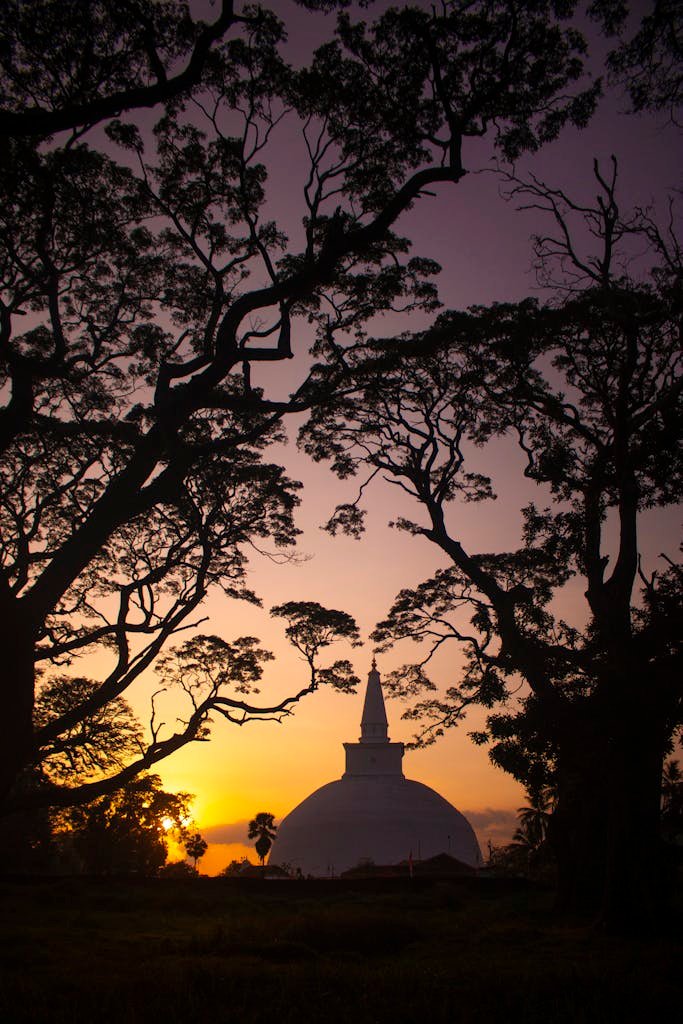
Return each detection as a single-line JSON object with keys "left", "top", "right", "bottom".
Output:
{"left": 270, "top": 662, "right": 481, "bottom": 878}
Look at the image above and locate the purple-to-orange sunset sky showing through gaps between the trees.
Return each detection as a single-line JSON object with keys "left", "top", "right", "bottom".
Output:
{"left": 113, "top": 2, "right": 681, "bottom": 872}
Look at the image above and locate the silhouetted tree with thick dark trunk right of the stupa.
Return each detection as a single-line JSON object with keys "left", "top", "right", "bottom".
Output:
{"left": 302, "top": 163, "right": 683, "bottom": 924}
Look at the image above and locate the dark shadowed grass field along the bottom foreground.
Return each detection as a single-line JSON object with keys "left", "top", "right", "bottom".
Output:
{"left": 0, "top": 879, "right": 683, "bottom": 1024}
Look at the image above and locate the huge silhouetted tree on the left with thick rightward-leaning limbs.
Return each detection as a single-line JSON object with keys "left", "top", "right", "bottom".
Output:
{"left": 0, "top": 0, "right": 597, "bottom": 807}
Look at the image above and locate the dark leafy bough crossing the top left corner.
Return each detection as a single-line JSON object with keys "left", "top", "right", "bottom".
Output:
{"left": 0, "top": 0, "right": 301, "bottom": 138}
